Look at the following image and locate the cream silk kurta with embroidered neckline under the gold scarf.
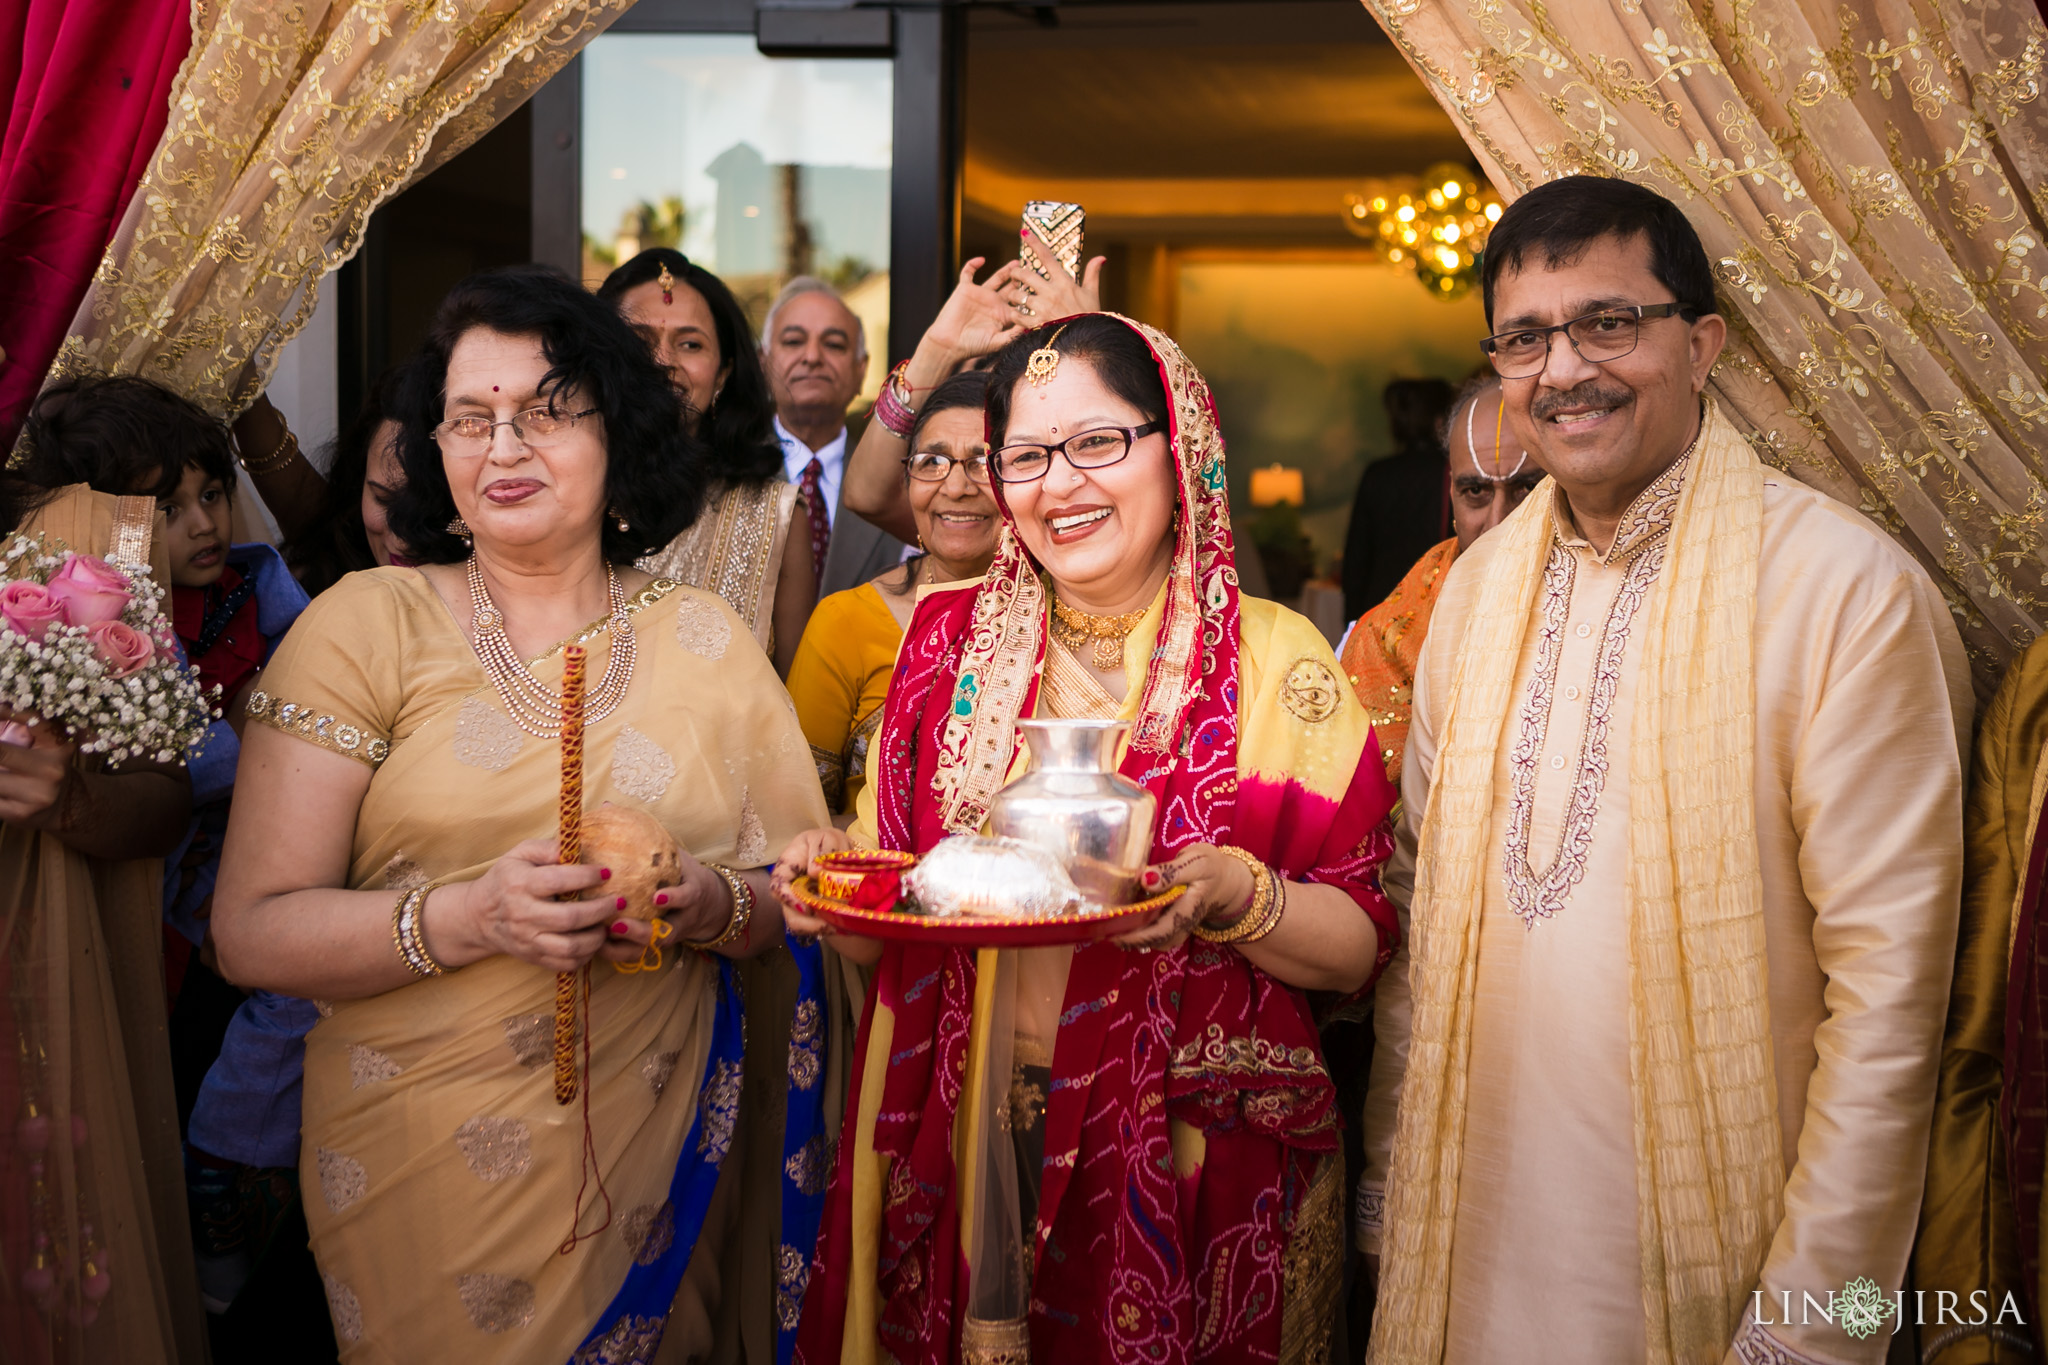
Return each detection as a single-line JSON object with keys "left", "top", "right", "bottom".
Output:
{"left": 1360, "top": 175, "right": 1970, "bottom": 1365}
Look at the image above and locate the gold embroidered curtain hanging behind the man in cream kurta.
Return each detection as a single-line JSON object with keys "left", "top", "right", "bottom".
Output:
{"left": 1364, "top": 0, "right": 2048, "bottom": 692}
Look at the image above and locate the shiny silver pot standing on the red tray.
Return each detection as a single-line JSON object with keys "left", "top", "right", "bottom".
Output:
{"left": 989, "top": 720, "right": 1159, "bottom": 905}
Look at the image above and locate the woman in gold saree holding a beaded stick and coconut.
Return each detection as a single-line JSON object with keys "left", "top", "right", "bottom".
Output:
{"left": 215, "top": 268, "right": 823, "bottom": 1361}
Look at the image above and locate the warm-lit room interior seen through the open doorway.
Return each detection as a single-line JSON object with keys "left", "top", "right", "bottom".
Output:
{"left": 961, "top": 0, "right": 1485, "bottom": 630}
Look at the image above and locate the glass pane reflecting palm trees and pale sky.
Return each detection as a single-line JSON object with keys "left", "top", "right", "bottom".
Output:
{"left": 582, "top": 33, "right": 893, "bottom": 399}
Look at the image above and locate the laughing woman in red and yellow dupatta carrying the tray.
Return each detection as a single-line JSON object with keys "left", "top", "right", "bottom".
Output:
{"left": 776, "top": 313, "right": 1397, "bottom": 1365}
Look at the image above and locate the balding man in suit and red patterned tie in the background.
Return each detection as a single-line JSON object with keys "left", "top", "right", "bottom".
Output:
{"left": 762, "top": 274, "right": 903, "bottom": 598}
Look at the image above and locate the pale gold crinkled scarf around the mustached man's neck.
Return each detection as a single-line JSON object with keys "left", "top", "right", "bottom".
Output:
{"left": 1370, "top": 403, "right": 1784, "bottom": 1365}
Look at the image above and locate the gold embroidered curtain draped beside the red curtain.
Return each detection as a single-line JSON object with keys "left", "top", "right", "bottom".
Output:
{"left": 51, "top": 0, "right": 633, "bottom": 417}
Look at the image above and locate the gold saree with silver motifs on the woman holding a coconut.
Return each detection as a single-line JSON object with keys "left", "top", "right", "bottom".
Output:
{"left": 250, "top": 569, "right": 825, "bottom": 1361}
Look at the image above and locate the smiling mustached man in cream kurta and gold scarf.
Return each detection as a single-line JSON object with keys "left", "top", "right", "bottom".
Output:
{"left": 1360, "top": 176, "right": 1970, "bottom": 1365}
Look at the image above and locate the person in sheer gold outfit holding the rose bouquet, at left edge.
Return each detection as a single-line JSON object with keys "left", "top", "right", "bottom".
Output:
{"left": 0, "top": 479, "right": 205, "bottom": 1365}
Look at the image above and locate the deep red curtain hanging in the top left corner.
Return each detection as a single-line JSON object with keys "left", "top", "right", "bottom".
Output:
{"left": 0, "top": 0, "right": 193, "bottom": 450}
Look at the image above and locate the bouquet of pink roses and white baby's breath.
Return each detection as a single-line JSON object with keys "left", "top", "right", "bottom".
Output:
{"left": 0, "top": 536, "right": 219, "bottom": 763}
